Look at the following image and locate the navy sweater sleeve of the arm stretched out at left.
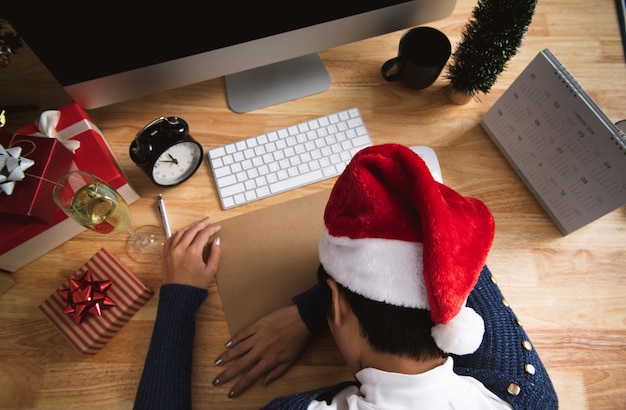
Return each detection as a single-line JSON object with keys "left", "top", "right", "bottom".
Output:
{"left": 134, "top": 284, "right": 208, "bottom": 409}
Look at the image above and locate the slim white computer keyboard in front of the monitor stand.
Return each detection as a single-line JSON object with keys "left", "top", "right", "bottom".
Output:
{"left": 207, "top": 108, "right": 372, "bottom": 209}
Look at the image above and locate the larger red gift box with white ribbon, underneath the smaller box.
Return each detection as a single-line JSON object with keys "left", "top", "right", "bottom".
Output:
{"left": 0, "top": 103, "right": 139, "bottom": 272}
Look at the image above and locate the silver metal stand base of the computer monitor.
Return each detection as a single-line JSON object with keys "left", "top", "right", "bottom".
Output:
{"left": 226, "top": 54, "right": 330, "bottom": 113}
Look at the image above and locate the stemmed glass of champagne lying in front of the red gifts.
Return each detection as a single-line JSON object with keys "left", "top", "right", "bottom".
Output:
{"left": 52, "top": 170, "right": 166, "bottom": 263}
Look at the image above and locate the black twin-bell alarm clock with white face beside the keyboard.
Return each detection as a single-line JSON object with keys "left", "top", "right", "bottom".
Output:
{"left": 130, "top": 117, "right": 203, "bottom": 186}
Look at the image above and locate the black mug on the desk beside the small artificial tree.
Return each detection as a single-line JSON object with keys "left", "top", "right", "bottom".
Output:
{"left": 381, "top": 27, "right": 452, "bottom": 90}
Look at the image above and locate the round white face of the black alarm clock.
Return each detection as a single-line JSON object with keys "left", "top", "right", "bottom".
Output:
{"left": 152, "top": 141, "right": 202, "bottom": 185}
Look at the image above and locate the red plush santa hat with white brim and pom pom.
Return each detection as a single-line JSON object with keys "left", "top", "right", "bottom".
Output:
{"left": 319, "top": 144, "right": 494, "bottom": 355}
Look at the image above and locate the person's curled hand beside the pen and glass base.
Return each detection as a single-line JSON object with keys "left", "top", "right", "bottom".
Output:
{"left": 161, "top": 217, "right": 222, "bottom": 289}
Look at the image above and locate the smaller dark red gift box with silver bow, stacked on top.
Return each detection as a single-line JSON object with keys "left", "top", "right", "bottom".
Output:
{"left": 0, "top": 134, "right": 74, "bottom": 225}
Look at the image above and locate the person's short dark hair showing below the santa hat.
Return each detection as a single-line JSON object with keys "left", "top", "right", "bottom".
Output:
{"left": 317, "top": 265, "right": 445, "bottom": 360}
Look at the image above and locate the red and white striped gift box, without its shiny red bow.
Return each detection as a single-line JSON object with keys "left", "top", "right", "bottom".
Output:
{"left": 39, "top": 248, "right": 154, "bottom": 354}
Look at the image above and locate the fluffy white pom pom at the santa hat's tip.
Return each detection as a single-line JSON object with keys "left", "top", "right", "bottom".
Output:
{"left": 431, "top": 307, "right": 485, "bottom": 355}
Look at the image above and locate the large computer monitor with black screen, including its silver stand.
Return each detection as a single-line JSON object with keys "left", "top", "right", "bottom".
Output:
{"left": 2, "top": 0, "right": 456, "bottom": 112}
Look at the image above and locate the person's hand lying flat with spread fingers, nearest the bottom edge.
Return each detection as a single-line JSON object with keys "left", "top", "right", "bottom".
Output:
{"left": 213, "top": 305, "right": 311, "bottom": 398}
